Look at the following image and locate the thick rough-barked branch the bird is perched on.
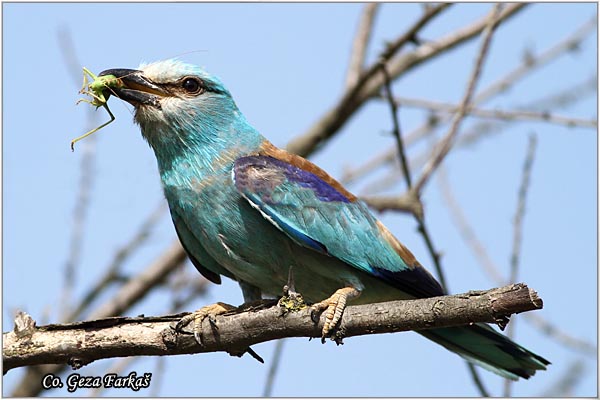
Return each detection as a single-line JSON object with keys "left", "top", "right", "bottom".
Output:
{"left": 3, "top": 284, "right": 543, "bottom": 373}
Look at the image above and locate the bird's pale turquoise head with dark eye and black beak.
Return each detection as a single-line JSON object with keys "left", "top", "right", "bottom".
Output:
{"left": 99, "top": 60, "right": 253, "bottom": 161}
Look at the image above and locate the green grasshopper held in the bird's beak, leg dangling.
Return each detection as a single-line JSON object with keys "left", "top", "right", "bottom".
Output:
{"left": 71, "top": 67, "right": 124, "bottom": 151}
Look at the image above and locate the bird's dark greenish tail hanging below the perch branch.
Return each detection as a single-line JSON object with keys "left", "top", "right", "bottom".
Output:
{"left": 419, "top": 324, "right": 550, "bottom": 380}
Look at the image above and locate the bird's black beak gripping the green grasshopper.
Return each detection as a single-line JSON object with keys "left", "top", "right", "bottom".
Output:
{"left": 98, "top": 69, "right": 169, "bottom": 108}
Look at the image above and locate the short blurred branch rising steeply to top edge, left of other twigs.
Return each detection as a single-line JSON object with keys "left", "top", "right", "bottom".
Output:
{"left": 346, "top": 3, "right": 380, "bottom": 88}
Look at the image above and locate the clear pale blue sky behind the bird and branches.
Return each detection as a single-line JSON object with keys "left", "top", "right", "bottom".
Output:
{"left": 2, "top": 3, "right": 598, "bottom": 397}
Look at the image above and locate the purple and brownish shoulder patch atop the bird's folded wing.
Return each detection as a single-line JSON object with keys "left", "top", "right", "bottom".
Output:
{"left": 234, "top": 156, "right": 351, "bottom": 203}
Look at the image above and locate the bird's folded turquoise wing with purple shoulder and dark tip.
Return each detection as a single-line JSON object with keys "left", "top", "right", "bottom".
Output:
{"left": 233, "top": 155, "right": 443, "bottom": 297}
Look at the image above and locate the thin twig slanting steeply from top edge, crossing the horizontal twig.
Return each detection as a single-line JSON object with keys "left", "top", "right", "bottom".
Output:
{"left": 414, "top": 3, "right": 501, "bottom": 193}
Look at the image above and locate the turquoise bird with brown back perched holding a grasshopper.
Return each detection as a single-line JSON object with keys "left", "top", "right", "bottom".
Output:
{"left": 99, "top": 59, "right": 550, "bottom": 380}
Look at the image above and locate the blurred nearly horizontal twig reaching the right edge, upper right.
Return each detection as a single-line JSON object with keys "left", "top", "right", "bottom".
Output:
{"left": 395, "top": 97, "right": 598, "bottom": 128}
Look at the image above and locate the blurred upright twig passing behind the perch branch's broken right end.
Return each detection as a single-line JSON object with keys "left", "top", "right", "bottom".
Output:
{"left": 504, "top": 134, "right": 537, "bottom": 397}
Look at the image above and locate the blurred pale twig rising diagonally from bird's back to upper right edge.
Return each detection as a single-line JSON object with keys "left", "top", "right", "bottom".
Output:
{"left": 341, "top": 16, "right": 597, "bottom": 184}
